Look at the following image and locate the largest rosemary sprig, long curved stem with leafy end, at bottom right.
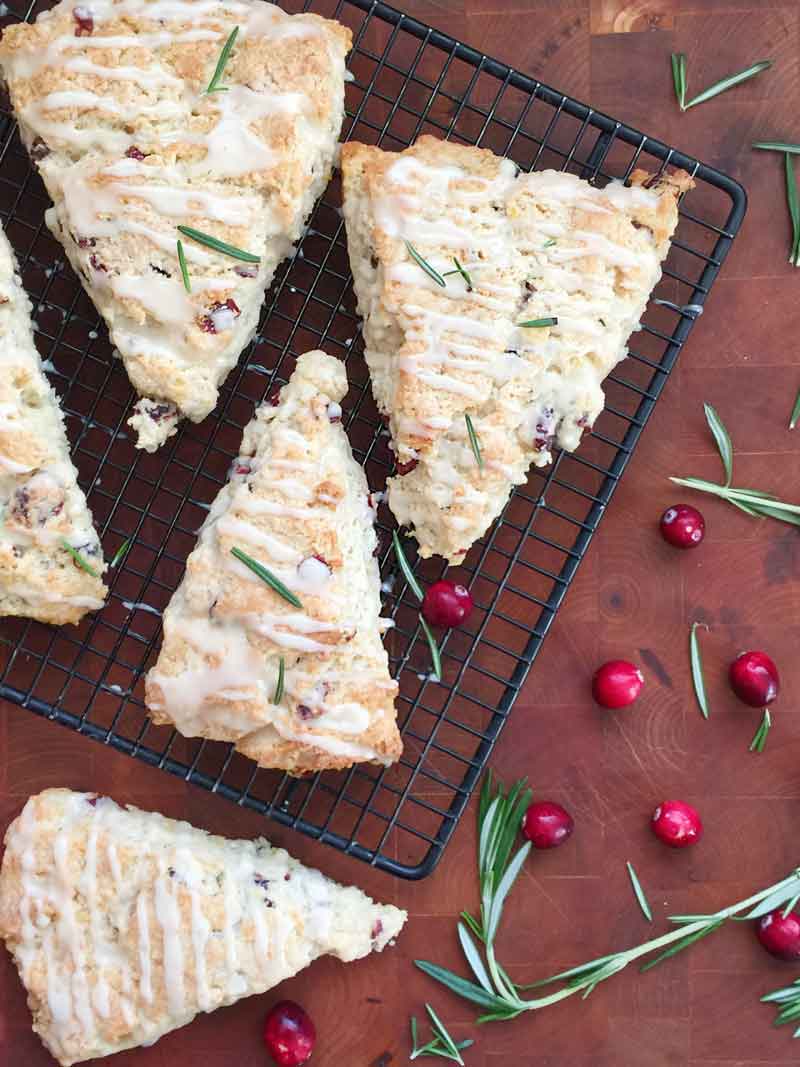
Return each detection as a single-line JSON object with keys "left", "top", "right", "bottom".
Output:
{"left": 415, "top": 775, "right": 800, "bottom": 1022}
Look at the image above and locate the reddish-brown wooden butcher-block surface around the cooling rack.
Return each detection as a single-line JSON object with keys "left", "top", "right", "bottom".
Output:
{"left": 0, "top": 0, "right": 800, "bottom": 1067}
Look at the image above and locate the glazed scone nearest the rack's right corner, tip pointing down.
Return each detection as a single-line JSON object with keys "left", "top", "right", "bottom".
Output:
{"left": 341, "top": 137, "right": 691, "bottom": 563}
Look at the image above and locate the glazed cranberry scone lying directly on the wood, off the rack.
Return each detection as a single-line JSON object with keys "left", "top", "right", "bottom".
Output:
{"left": 0, "top": 790, "right": 406, "bottom": 1065}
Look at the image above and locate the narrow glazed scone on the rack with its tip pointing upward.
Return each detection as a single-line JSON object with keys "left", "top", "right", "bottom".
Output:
{"left": 146, "top": 352, "right": 401, "bottom": 774}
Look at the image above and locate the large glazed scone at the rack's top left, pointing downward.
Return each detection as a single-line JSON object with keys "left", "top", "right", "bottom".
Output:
{"left": 0, "top": 0, "right": 351, "bottom": 451}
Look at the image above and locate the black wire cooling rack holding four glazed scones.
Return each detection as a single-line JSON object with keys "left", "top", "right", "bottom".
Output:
{"left": 0, "top": 0, "right": 746, "bottom": 878}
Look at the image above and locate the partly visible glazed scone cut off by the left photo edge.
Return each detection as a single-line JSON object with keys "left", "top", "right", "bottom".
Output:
{"left": 0, "top": 229, "right": 106, "bottom": 623}
